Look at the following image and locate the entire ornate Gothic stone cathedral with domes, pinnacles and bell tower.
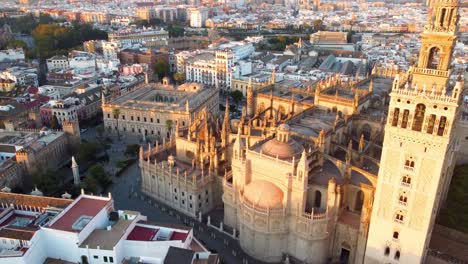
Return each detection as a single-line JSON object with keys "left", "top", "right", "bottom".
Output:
{"left": 140, "top": 0, "right": 464, "bottom": 263}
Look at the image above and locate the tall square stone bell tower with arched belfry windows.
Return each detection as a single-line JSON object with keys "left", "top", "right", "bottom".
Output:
{"left": 365, "top": 0, "right": 463, "bottom": 264}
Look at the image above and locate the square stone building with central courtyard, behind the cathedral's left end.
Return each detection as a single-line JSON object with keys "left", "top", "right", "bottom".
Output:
{"left": 102, "top": 79, "right": 219, "bottom": 139}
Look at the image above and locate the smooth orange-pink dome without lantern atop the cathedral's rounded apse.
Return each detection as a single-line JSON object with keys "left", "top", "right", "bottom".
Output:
{"left": 244, "top": 180, "right": 284, "bottom": 208}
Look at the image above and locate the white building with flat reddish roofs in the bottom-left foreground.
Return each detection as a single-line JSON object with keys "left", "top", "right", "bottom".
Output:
{"left": 0, "top": 193, "right": 217, "bottom": 264}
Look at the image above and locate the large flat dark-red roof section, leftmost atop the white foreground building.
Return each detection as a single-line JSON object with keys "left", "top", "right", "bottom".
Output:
{"left": 50, "top": 197, "right": 111, "bottom": 233}
